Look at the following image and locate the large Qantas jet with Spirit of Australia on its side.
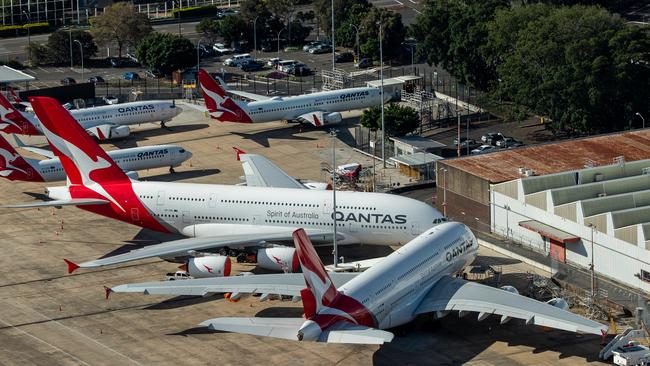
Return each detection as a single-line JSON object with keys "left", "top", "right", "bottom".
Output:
{"left": 5, "top": 97, "right": 445, "bottom": 271}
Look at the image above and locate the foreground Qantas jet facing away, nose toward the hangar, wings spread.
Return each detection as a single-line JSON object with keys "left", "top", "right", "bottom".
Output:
{"left": 107, "top": 222, "right": 607, "bottom": 344}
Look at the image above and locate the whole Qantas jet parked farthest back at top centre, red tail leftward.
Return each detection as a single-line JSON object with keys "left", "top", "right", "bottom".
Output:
{"left": 199, "top": 69, "right": 381, "bottom": 127}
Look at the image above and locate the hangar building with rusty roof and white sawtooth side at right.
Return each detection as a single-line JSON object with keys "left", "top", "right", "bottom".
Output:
{"left": 436, "top": 130, "right": 650, "bottom": 297}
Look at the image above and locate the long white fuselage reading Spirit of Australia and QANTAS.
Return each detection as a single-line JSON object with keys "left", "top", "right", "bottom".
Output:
{"left": 48, "top": 182, "right": 443, "bottom": 245}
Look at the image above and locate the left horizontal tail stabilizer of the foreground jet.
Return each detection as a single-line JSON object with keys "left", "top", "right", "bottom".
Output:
{"left": 201, "top": 318, "right": 305, "bottom": 341}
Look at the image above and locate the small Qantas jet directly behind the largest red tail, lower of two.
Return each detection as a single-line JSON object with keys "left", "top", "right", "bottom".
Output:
{"left": 0, "top": 135, "right": 192, "bottom": 182}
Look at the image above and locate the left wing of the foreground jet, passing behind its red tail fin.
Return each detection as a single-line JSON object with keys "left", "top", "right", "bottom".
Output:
{"left": 111, "top": 273, "right": 358, "bottom": 296}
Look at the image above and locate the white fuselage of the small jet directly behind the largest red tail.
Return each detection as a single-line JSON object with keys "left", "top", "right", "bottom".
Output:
{"left": 26, "top": 145, "right": 192, "bottom": 182}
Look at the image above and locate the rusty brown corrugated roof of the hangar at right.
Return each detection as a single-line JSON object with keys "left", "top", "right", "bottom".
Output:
{"left": 440, "top": 129, "right": 650, "bottom": 183}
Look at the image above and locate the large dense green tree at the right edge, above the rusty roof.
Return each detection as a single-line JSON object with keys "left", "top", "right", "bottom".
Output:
{"left": 488, "top": 5, "right": 650, "bottom": 134}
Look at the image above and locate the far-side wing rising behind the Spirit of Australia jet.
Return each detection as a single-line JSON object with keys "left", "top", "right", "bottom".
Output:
{"left": 239, "top": 154, "right": 307, "bottom": 189}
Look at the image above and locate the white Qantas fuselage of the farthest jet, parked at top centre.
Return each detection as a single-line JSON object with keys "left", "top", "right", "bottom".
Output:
{"left": 240, "top": 87, "right": 381, "bottom": 122}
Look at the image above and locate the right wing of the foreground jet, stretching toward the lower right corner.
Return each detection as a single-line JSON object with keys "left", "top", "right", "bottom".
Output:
{"left": 415, "top": 276, "right": 607, "bottom": 335}
